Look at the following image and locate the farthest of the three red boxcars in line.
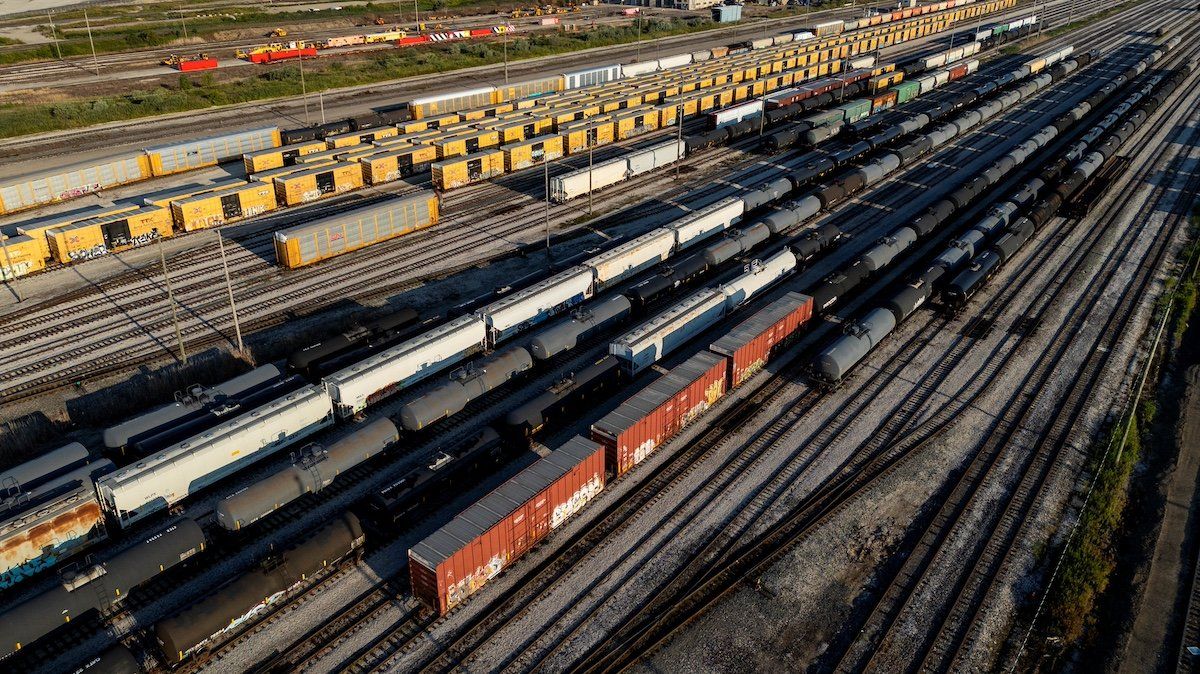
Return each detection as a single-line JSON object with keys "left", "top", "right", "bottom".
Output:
{"left": 709, "top": 293, "right": 812, "bottom": 389}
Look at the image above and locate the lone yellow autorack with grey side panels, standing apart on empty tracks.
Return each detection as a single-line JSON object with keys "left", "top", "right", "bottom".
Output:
{"left": 275, "top": 191, "right": 438, "bottom": 269}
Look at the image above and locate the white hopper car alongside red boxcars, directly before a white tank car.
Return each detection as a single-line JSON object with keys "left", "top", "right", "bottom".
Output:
{"left": 608, "top": 288, "right": 725, "bottom": 374}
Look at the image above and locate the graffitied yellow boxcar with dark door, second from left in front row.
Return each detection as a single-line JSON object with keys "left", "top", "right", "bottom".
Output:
{"left": 46, "top": 206, "right": 173, "bottom": 264}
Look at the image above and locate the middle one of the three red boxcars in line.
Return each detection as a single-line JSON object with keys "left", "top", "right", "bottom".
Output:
{"left": 592, "top": 351, "right": 728, "bottom": 477}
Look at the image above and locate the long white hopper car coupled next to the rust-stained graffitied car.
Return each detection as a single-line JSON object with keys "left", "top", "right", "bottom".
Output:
{"left": 96, "top": 386, "right": 334, "bottom": 528}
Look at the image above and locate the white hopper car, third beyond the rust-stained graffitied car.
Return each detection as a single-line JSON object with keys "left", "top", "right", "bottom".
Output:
{"left": 478, "top": 266, "right": 593, "bottom": 344}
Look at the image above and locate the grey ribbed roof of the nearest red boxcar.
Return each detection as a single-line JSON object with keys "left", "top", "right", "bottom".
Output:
{"left": 410, "top": 437, "right": 600, "bottom": 568}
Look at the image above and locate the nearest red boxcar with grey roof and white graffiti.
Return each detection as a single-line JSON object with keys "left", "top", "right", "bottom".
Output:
{"left": 408, "top": 437, "right": 605, "bottom": 614}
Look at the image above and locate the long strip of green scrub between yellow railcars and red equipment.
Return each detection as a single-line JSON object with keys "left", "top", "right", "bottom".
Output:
{"left": 0, "top": 19, "right": 715, "bottom": 137}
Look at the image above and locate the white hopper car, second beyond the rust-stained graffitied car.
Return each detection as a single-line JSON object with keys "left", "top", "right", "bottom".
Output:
{"left": 324, "top": 315, "right": 487, "bottom": 417}
